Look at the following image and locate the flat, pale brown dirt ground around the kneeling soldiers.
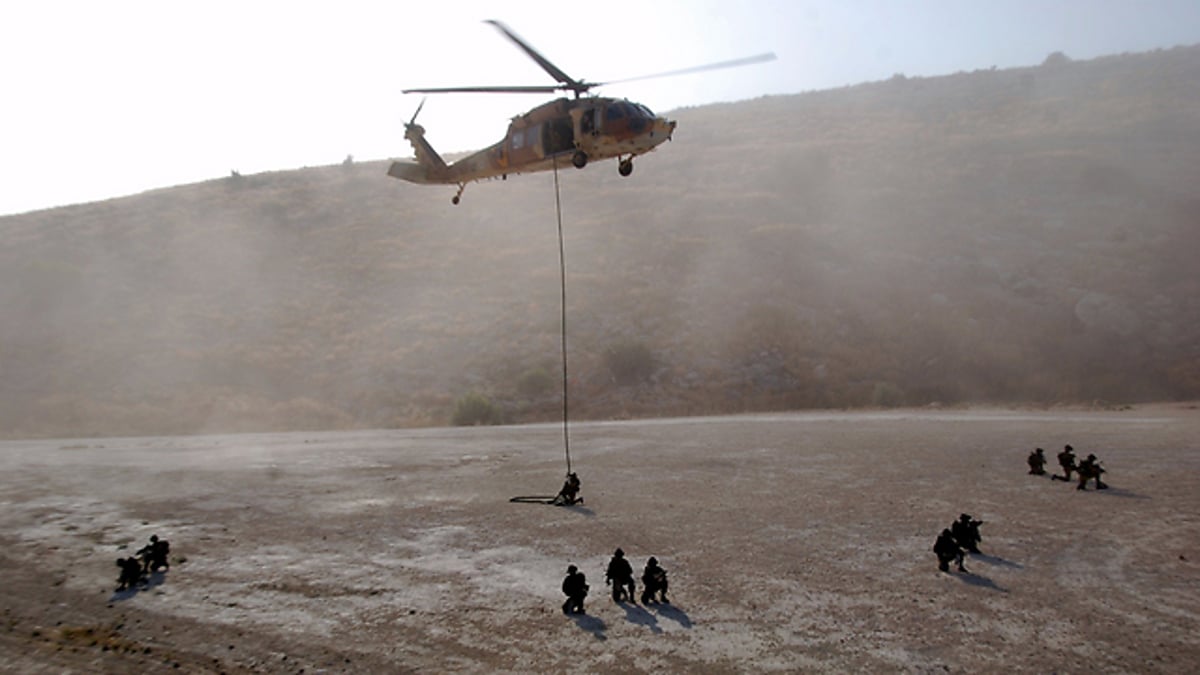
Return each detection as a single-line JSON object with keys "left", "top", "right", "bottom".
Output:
{"left": 0, "top": 405, "right": 1200, "bottom": 673}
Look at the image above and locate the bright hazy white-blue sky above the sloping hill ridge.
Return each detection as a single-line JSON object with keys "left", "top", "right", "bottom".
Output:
{"left": 0, "top": 0, "right": 1200, "bottom": 215}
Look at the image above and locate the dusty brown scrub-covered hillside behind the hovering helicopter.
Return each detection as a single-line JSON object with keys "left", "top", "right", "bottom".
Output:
{"left": 0, "top": 47, "right": 1200, "bottom": 437}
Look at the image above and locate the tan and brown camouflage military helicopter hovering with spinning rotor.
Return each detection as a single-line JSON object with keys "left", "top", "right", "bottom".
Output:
{"left": 388, "top": 20, "right": 775, "bottom": 204}
